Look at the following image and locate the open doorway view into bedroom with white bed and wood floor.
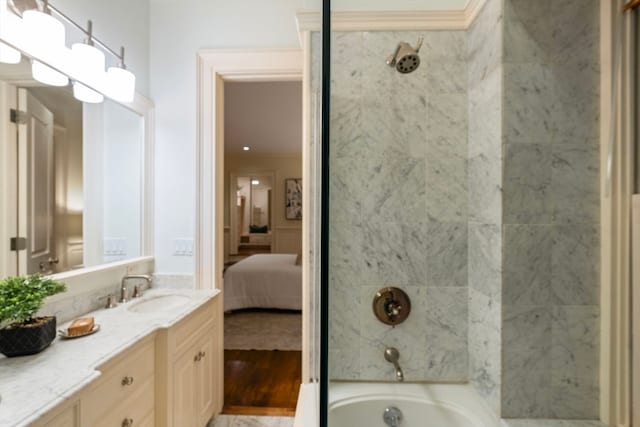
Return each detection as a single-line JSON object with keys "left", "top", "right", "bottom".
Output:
{"left": 222, "top": 80, "right": 304, "bottom": 416}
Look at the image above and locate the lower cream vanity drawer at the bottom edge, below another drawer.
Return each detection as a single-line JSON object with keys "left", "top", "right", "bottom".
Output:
{"left": 91, "top": 378, "right": 155, "bottom": 427}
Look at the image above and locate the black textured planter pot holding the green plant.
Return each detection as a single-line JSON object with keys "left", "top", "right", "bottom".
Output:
{"left": 0, "top": 316, "right": 56, "bottom": 357}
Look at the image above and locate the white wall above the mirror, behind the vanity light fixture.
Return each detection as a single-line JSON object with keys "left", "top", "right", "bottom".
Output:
{"left": 51, "top": 0, "right": 149, "bottom": 95}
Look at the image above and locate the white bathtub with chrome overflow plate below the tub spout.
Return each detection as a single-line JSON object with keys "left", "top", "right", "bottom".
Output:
{"left": 329, "top": 382, "right": 504, "bottom": 427}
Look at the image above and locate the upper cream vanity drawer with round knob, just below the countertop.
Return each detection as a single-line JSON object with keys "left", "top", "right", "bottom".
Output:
{"left": 82, "top": 340, "right": 155, "bottom": 425}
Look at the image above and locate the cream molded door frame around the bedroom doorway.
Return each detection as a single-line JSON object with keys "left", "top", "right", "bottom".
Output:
{"left": 194, "top": 47, "right": 311, "bottom": 392}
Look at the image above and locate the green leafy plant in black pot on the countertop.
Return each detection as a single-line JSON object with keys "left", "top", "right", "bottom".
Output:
{"left": 0, "top": 274, "right": 66, "bottom": 357}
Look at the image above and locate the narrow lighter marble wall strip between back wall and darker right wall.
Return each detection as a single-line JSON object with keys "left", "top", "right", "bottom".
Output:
{"left": 467, "top": 0, "right": 503, "bottom": 413}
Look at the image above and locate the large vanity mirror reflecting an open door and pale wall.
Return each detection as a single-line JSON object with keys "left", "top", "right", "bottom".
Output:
{"left": 0, "top": 55, "right": 150, "bottom": 277}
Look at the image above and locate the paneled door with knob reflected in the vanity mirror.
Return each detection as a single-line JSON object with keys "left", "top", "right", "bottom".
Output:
{"left": 18, "top": 89, "right": 57, "bottom": 274}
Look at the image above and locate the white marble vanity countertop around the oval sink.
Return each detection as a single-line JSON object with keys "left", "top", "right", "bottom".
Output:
{"left": 0, "top": 289, "right": 219, "bottom": 426}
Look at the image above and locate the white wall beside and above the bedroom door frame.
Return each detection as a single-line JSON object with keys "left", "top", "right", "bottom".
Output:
{"left": 150, "top": 0, "right": 302, "bottom": 273}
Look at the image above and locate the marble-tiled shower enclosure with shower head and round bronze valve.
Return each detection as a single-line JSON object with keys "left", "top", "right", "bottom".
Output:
{"left": 320, "top": 0, "right": 601, "bottom": 427}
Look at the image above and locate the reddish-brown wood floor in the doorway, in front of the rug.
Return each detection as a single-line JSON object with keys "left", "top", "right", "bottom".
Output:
{"left": 222, "top": 350, "right": 302, "bottom": 416}
